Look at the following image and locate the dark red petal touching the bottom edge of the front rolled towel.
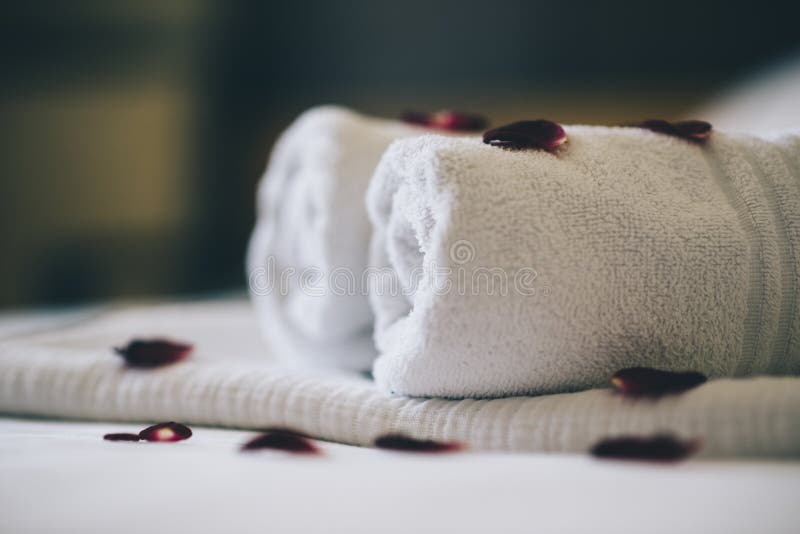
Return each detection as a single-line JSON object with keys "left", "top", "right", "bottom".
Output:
{"left": 611, "top": 367, "right": 707, "bottom": 397}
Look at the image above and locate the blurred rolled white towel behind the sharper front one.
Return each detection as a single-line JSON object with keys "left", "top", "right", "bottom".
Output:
{"left": 247, "top": 106, "right": 425, "bottom": 370}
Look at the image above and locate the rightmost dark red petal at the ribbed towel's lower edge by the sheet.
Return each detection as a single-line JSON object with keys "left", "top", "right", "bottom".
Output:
{"left": 590, "top": 435, "right": 701, "bottom": 462}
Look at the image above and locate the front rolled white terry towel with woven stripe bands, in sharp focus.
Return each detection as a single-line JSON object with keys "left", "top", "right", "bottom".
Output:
{"left": 367, "top": 126, "right": 800, "bottom": 397}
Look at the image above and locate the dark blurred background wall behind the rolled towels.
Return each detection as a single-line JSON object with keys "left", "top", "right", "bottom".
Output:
{"left": 0, "top": 0, "right": 800, "bottom": 307}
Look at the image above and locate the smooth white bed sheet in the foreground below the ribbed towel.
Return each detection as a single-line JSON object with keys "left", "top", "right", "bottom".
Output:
{"left": 0, "top": 419, "right": 800, "bottom": 534}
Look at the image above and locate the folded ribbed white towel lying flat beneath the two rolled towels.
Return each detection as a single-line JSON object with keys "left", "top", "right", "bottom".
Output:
{"left": 0, "top": 301, "right": 800, "bottom": 457}
